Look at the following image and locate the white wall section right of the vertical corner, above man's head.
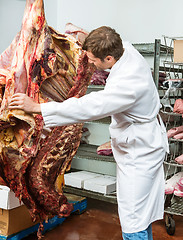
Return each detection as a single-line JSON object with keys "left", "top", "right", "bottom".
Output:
{"left": 58, "top": 0, "right": 183, "bottom": 43}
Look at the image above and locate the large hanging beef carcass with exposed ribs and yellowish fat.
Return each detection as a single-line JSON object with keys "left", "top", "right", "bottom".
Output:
{"left": 0, "top": 0, "right": 94, "bottom": 235}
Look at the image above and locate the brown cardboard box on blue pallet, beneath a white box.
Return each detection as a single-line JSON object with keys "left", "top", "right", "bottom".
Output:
{"left": 0, "top": 205, "right": 38, "bottom": 236}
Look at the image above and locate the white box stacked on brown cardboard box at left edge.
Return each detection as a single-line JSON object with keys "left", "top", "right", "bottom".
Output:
{"left": 0, "top": 185, "right": 23, "bottom": 210}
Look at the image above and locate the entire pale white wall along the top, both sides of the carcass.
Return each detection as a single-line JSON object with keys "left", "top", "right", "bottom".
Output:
{"left": 0, "top": 0, "right": 183, "bottom": 53}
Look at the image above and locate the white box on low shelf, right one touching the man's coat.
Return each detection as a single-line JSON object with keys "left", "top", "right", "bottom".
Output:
{"left": 84, "top": 175, "right": 116, "bottom": 194}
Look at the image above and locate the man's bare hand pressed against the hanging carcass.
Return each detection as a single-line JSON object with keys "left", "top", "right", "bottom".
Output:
{"left": 9, "top": 93, "right": 41, "bottom": 114}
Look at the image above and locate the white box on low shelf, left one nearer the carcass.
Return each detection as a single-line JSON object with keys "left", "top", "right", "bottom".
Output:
{"left": 64, "top": 171, "right": 101, "bottom": 188}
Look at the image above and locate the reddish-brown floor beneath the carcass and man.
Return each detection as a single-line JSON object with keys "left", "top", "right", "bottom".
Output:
{"left": 24, "top": 199, "right": 183, "bottom": 240}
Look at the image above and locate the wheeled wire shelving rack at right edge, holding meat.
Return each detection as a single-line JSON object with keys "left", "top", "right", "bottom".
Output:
{"left": 161, "top": 36, "right": 183, "bottom": 235}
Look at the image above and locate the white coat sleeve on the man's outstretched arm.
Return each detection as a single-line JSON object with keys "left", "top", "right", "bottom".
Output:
{"left": 41, "top": 79, "right": 135, "bottom": 127}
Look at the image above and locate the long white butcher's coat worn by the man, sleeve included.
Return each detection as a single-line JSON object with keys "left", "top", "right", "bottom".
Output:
{"left": 41, "top": 42, "right": 168, "bottom": 233}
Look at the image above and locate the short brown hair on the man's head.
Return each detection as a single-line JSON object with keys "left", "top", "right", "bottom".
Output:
{"left": 83, "top": 26, "right": 124, "bottom": 61}
